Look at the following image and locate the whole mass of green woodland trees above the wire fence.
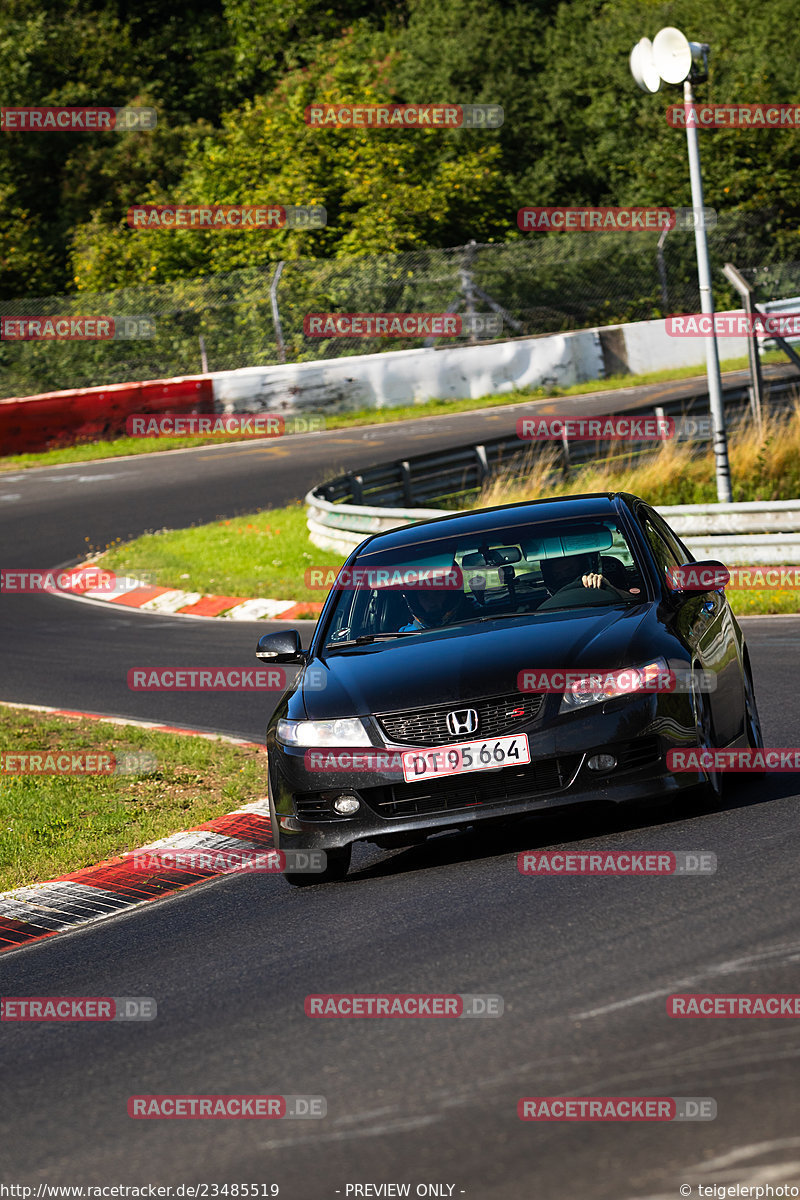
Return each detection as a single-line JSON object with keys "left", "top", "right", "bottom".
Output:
{"left": 0, "top": 0, "right": 800, "bottom": 299}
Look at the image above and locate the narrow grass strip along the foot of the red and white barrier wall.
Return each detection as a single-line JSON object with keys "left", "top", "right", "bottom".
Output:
{"left": 0, "top": 352, "right": 784, "bottom": 473}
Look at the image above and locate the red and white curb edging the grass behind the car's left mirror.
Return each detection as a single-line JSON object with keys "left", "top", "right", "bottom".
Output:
{"left": 56, "top": 563, "right": 323, "bottom": 620}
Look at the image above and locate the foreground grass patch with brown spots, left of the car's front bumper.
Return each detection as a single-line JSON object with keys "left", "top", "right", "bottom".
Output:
{"left": 0, "top": 707, "right": 266, "bottom": 892}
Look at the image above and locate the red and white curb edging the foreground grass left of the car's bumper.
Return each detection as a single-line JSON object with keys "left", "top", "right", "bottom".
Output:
{"left": 0, "top": 701, "right": 272, "bottom": 953}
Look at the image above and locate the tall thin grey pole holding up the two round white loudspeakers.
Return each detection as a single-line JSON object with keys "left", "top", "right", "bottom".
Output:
{"left": 684, "top": 79, "right": 732, "bottom": 504}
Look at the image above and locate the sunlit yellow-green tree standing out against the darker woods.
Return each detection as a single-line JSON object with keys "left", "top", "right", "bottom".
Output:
{"left": 76, "top": 22, "right": 512, "bottom": 290}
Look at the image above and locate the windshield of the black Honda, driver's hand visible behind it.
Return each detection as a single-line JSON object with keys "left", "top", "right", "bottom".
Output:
{"left": 325, "top": 517, "right": 645, "bottom": 647}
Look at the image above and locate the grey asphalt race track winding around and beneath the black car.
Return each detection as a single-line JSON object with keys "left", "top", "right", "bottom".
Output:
{"left": 0, "top": 396, "right": 800, "bottom": 1200}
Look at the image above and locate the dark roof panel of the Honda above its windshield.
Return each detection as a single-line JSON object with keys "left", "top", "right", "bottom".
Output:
{"left": 359, "top": 492, "right": 634, "bottom": 557}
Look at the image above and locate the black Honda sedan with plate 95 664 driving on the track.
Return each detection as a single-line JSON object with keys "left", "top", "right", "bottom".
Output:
{"left": 257, "top": 492, "right": 763, "bottom": 884}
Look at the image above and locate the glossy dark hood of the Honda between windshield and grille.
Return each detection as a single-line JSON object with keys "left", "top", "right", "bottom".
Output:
{"left": 299, "top": 605, "right": 656, "bottom": 720}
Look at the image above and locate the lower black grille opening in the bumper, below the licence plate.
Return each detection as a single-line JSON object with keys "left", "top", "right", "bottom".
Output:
{"left": 360, "top": 755, "right": 581, "bottom": 817}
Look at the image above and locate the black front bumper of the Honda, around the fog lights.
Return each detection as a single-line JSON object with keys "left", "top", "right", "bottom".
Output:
{"left": 267, "top": 695, "right": 704, "bottom": 850}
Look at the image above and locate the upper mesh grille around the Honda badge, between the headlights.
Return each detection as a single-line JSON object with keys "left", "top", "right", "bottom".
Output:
{"left": 375, "top": 691, "right": 545, "bottom": 746}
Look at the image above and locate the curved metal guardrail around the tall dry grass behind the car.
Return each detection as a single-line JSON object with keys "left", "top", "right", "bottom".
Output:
{"left": 306, "top": 383, "right": 800, "bottom": 564}
